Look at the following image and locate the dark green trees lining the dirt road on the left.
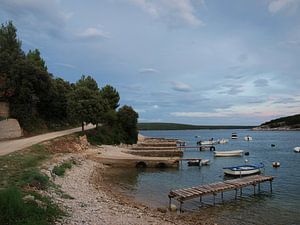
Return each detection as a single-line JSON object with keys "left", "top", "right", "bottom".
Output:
{"left": 0, "top": 21, "right": 138, "bottom": 143}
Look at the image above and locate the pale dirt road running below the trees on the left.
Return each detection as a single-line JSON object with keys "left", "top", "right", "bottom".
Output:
{"left": 0, "top": 125, "right": 94, "bottom": 156}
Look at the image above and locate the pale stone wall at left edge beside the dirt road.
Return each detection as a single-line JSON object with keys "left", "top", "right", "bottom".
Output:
{"left": 0, "top": 119, "right": 23, "bottom": 140}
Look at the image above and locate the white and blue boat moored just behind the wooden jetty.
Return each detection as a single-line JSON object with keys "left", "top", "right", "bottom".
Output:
{"left": 223, "top": 163, "right": 264, "bottom": 176}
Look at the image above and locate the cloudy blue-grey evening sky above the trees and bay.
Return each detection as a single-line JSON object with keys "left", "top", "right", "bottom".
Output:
{"left": 0, "top": 0, "right": 300, "bottom": 125}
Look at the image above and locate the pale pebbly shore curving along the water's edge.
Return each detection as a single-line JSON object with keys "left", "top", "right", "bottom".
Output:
{"left": 50, "top": 145, "right": 211, "bottom": 225}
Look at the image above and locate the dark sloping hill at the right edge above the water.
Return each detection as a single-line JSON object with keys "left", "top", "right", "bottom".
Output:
{"left": 254, "top": 114, "right": 300, "bottom": 130}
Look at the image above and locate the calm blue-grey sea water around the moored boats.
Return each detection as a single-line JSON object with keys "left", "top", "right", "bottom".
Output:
{"left": 105, "top": 130, "right": 300, "bottom": 225}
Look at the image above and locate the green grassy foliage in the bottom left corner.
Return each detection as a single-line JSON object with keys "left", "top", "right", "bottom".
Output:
{"left": 0, "top": 187, "right": 63, "bottom": 225}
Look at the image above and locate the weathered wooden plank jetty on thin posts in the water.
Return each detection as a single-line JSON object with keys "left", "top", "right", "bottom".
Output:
{"left": 169, "top": 175, "right": 274, "bottom": 212}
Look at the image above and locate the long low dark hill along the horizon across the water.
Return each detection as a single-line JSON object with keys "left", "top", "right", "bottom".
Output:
{"left": 138, "top": 123, "right": 254, "bottom": 130}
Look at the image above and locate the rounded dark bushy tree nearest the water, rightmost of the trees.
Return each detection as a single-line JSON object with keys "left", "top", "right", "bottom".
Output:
{"left": 118, "top": 105, "right": 139, "bottom": 144}
